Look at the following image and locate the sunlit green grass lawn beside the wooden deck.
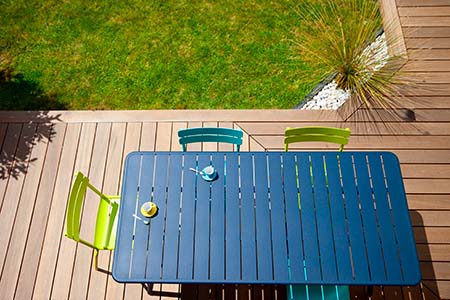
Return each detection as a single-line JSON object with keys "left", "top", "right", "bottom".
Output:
{"left": 0, "top": 0, "right": 324, "bottom": 109}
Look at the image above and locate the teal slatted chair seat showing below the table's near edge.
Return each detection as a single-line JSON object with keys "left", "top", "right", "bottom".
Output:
{"left": 287, "top": 284, "right": 350, "bottom": 300}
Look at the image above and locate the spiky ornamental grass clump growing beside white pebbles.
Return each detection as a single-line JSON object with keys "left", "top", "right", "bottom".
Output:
{"left": 295, "top": 0, "right": 403, "bottom": 109}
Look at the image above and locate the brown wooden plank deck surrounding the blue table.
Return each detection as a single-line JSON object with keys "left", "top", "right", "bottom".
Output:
{"left": 0, "top": 0, "right": 450, "bottom": 300}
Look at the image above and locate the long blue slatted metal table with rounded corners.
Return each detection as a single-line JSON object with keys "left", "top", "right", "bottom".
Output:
{"left": 113, "top": 152, "right": 421, "bottom": 285}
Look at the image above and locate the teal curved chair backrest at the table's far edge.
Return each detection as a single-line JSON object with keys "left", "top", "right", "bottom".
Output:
{"left": 178, "top": 127, "right": 243, "bottom": 151}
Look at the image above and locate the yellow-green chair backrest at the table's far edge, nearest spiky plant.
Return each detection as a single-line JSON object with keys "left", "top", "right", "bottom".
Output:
{"left": 284, "top": 126, "right": 351, "bottom": 151}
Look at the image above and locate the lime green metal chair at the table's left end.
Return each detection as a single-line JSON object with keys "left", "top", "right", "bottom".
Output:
{"left": 65, "top": 172, "right": 120, "bottom": 270}
